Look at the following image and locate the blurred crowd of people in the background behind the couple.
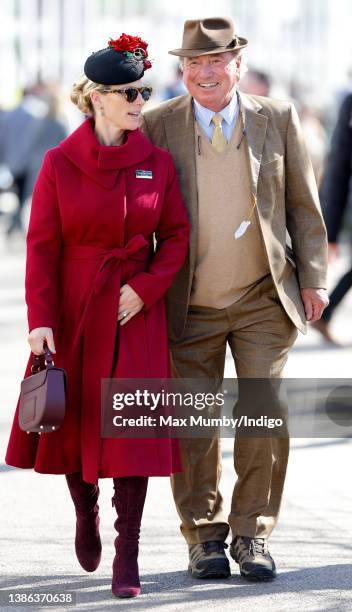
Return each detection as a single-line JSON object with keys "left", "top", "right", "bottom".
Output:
{"left": 0, "top": 65, "right": 352, "bottom": 346}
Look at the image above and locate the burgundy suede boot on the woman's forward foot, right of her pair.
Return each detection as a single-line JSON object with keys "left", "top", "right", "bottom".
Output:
{"left": 112, "top": 476, "right": 148, "bottom": 597}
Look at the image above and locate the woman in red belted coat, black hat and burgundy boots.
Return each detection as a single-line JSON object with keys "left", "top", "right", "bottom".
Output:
{"left": 6, "top": 34, "right": 189, "bottom": 597}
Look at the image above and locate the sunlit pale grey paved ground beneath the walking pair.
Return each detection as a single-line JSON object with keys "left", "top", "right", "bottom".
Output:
{"left": 0, "top": 226, "right": 352, "bottom": 612}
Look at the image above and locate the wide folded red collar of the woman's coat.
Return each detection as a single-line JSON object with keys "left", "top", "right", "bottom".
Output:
{"left": 59, "top": 118, "right": 153, "bottom": 189}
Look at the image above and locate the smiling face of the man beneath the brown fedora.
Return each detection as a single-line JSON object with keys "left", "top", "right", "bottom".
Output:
{"left": 183, "top": 51, "right": 241, "bottom": 113}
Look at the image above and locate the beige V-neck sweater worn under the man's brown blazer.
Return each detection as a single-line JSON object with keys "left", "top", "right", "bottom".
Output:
{"left": 190, "top": 116, "right": 270, "bottom": 308}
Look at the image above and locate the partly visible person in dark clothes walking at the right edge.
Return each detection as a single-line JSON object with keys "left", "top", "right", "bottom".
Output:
{"left": 313, "top": 94, "right": 352, "bottom": 346}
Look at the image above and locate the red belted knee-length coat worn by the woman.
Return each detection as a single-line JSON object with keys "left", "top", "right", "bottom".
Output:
{"left": 6, "top": 119, "right": 189, "bottom": 482}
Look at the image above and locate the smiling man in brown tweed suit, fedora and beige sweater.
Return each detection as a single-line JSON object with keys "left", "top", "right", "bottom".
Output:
{"left": 143, "top": 18, "right": 328, "bottom": 580}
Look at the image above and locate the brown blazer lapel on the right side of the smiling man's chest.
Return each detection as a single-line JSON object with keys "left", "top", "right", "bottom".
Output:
{"left": 239, "top": 93, "right": 268, "bottom": 196}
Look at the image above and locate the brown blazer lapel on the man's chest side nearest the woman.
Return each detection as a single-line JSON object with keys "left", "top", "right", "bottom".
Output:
{"left": 163, "top": 95, "right": 198, "bottom": 270}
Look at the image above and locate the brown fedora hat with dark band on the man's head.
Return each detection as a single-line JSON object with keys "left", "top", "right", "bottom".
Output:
{"left": 169, "top": 17, "right": 248, "bottom": 57}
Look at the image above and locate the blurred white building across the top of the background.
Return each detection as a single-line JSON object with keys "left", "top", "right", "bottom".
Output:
{"left": 0, "top": 0, "right": 352, "bottom": 107}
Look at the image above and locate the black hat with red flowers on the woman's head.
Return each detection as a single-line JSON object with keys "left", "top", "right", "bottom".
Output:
{"left": 84, "top": 34, "right": 151, "bottom": 85}
